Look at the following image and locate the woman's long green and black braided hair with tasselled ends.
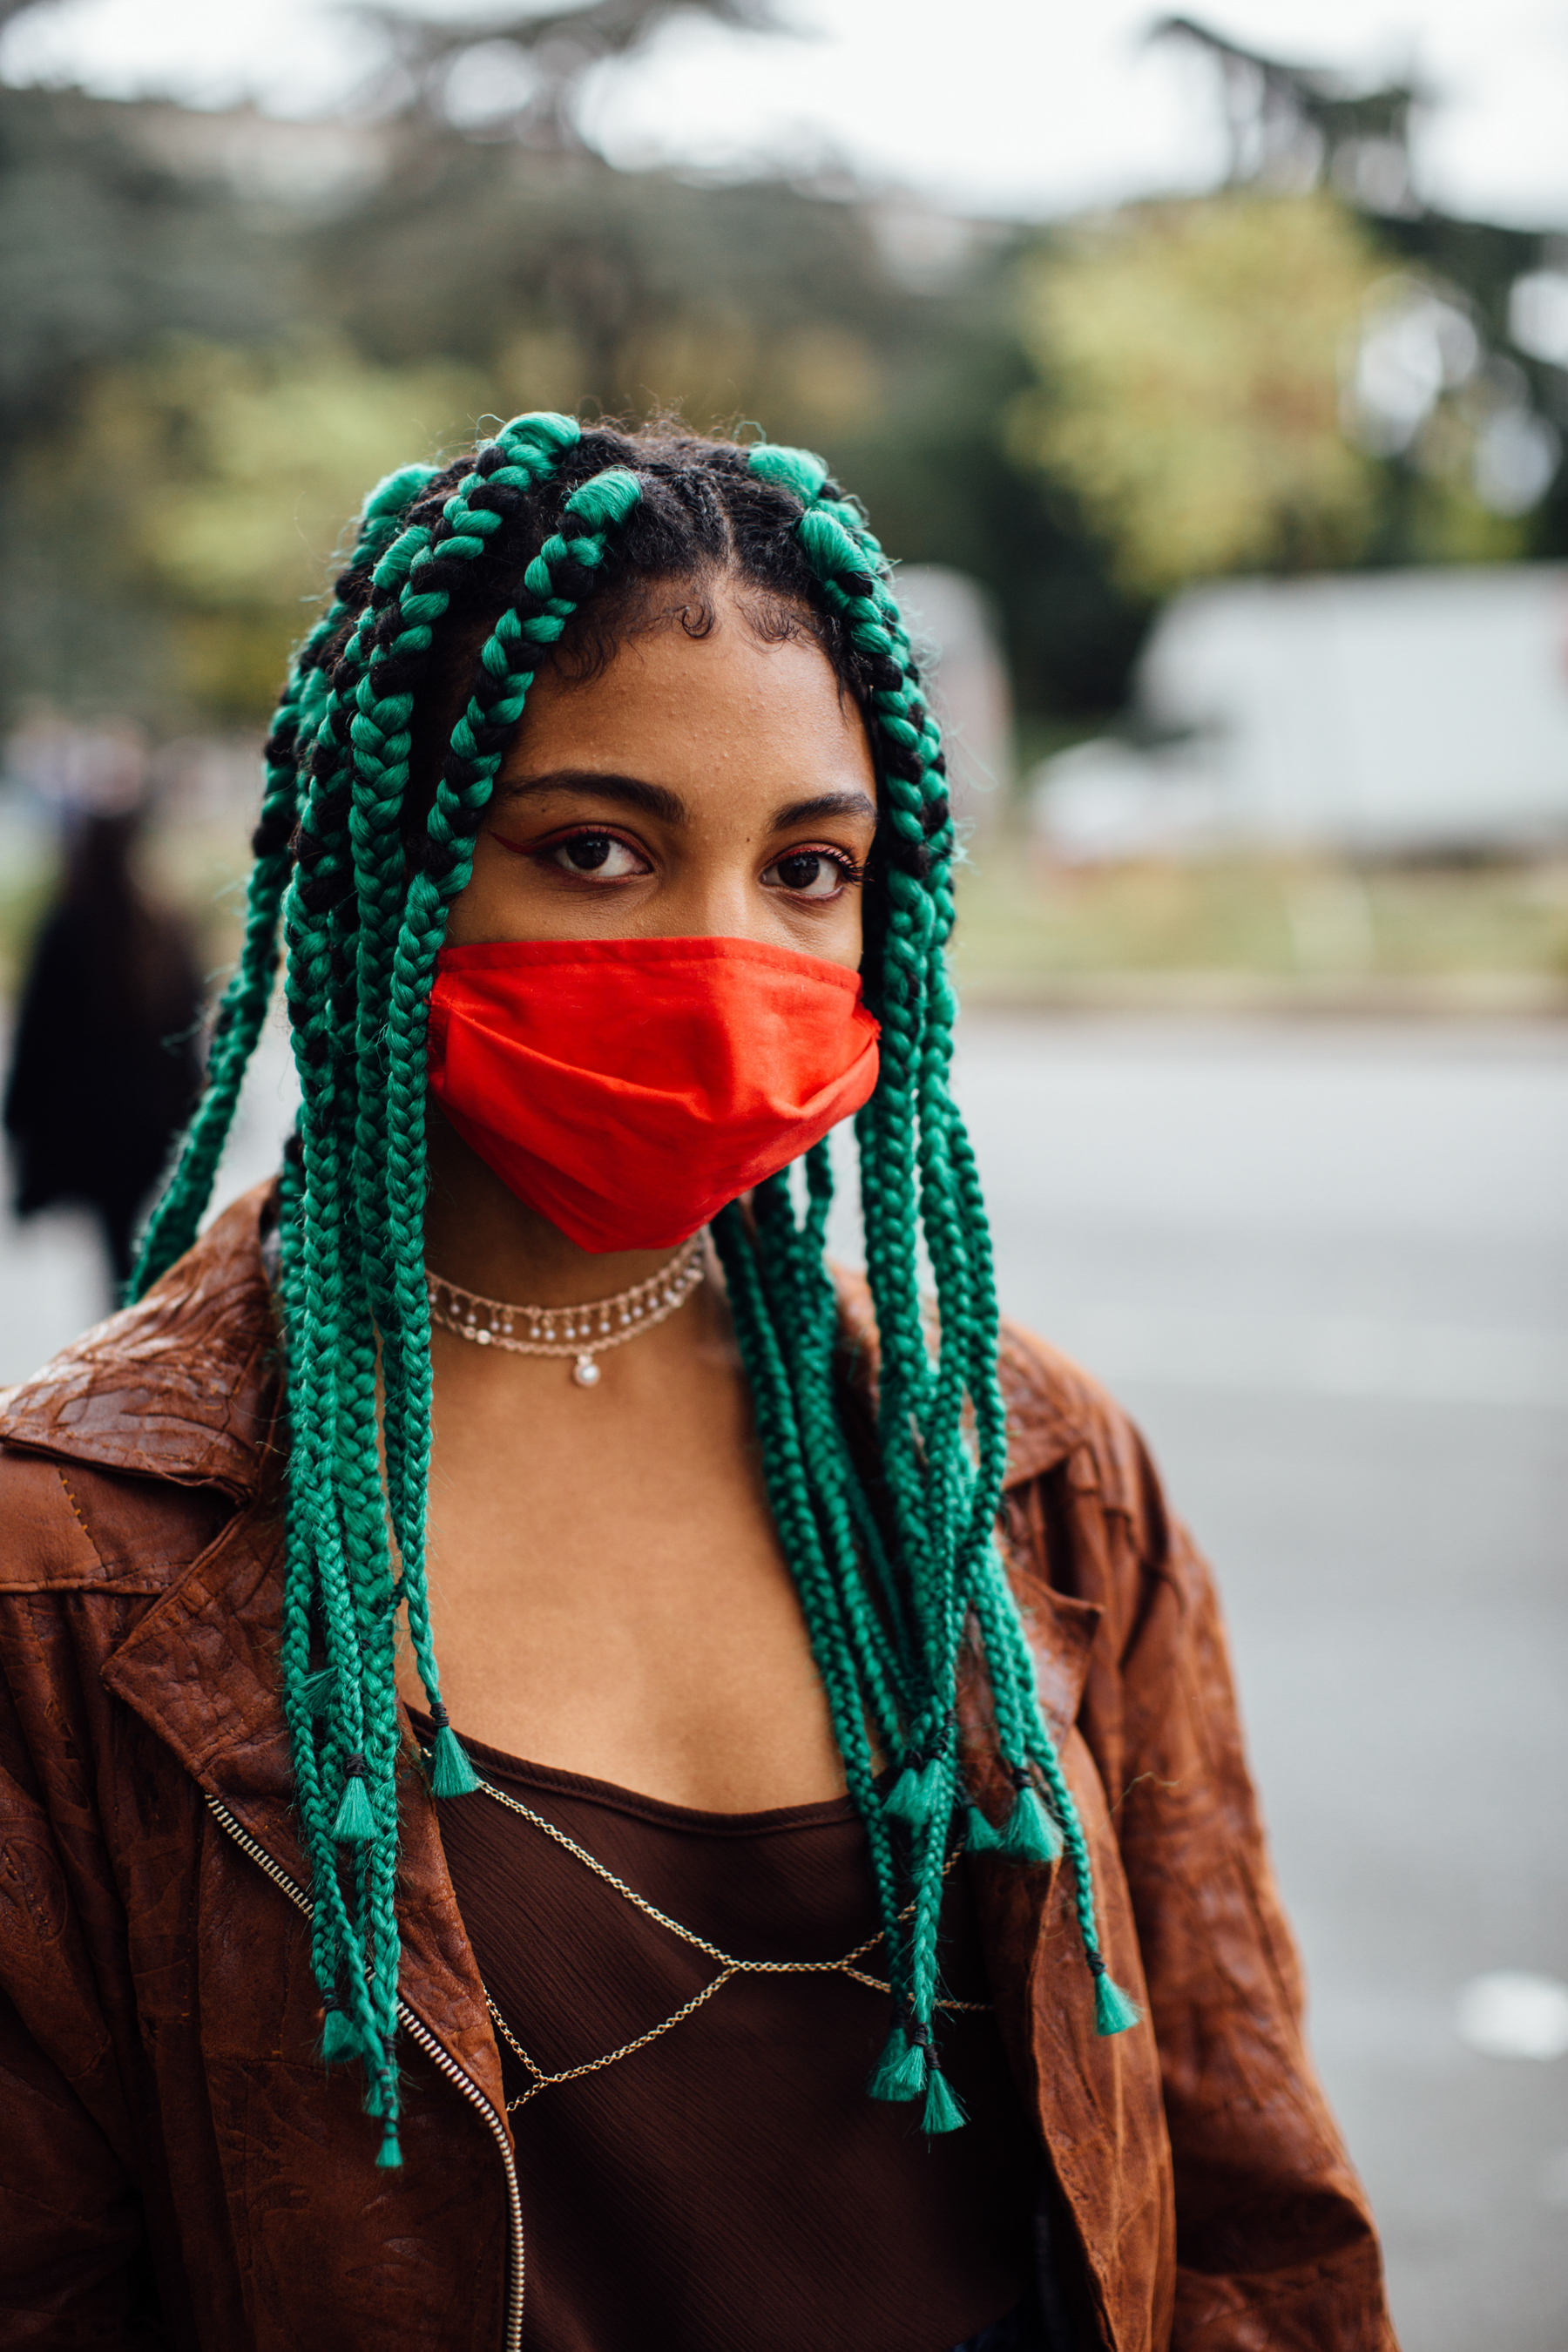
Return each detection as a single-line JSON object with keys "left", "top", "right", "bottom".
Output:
{"left": 134, "top": 414, "right": 1138, "bottom": 2166}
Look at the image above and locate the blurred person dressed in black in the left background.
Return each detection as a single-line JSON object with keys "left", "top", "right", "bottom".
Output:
{"left": 4, "top": 795, "right": 202, "bottom": 1303}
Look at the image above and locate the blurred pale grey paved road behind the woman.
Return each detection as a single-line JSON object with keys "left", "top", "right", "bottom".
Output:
{"left": 0, "top": 1018, "right": 1568, "bottom": 2352}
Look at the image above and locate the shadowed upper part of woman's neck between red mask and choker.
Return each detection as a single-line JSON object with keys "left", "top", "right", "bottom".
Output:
{"left": 425, "top": 1101, "right": 691, "bottom": 1308}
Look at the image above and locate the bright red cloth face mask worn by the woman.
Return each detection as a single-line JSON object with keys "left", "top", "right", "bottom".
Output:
{"left": 430, "top": 938, "right": 877, "bottom": 1251}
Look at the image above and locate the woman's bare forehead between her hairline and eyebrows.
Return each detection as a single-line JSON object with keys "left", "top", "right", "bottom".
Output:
{"left": 498, "top": 598, "right": 875, "bottom": 800}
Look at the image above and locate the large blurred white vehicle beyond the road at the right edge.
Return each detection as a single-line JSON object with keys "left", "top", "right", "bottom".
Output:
{"left": 1032, "top": 564, "right": 1568, "bottom": 861}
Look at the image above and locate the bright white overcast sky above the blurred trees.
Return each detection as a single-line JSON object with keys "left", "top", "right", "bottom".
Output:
{"left": 0, "top": 0, "right": 1568, "bottom": 231}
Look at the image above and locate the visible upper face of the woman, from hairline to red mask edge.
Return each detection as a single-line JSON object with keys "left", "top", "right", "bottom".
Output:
{"left": 447, "top": 591, "right": 877, "bottom": 969}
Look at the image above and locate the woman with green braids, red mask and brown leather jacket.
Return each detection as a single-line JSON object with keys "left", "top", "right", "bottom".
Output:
{"left": 0, "top": 416, "right": 1392, "bottom": 2352}
